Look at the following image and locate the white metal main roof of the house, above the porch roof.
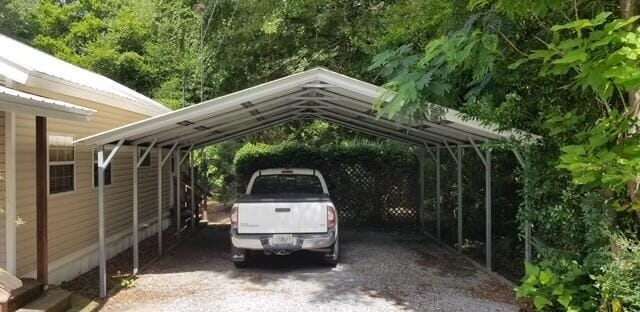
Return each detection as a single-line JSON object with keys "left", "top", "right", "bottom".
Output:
{"left": 0, "top": 34, "right": 170, "bottom": 116}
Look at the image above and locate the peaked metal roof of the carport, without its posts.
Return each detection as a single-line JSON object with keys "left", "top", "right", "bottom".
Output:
{"left": 76, "top": 68, "right": 536, "bottom": 148}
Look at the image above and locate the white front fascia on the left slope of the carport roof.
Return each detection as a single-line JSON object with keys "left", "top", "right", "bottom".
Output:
{"left": 75, "top": 71, "right": 316, "bottom": 145}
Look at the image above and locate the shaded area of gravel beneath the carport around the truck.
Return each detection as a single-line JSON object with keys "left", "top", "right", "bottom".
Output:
{"left": 134, "top": 226, "right": 513, "bottom": 311}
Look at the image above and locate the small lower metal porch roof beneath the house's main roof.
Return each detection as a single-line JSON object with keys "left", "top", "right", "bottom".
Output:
{"left": 0, "top": 86, "right": 96, "bottom": 121}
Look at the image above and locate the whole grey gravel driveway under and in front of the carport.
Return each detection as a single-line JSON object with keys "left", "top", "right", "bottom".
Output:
{"left": 104, "top": 228, "right": 518, "bottom": 312}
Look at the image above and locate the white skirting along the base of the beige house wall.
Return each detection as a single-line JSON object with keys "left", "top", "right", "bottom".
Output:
{"left": 21, "top": 212, "right": 171, "bottom": 284}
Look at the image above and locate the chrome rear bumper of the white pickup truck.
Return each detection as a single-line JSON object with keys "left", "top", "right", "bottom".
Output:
{"left": 230, "top": 229, "right": 337, "bottom": 251}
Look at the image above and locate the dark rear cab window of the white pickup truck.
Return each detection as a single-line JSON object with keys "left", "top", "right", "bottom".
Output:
{"left": 251, "top": 174, "right": 323, "bottom": 194}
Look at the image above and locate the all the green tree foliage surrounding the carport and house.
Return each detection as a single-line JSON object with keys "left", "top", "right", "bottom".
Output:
{"left": 0, "top": 0, "right": 640, "bottom": 311}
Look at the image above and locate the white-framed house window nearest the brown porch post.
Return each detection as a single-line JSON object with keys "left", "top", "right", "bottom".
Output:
{"left": 49, "top": 135, "right": 75, "bottom": 194}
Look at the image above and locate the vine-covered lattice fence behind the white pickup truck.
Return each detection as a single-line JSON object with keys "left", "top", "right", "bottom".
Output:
{"left": 235, "top": 144, "right": 419, "bottom": 228}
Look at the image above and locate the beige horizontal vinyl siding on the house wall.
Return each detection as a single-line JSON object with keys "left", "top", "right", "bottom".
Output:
{"left": 16, "top": 90, "right": 170, "bottom": 275}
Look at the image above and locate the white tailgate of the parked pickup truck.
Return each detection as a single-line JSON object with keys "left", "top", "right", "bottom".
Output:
{"left": 238, "top": 201, "right": 327, "bottom": 234}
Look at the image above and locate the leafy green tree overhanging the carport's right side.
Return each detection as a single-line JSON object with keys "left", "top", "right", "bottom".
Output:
{"left": 371, "top": 0, "right": 640, "bottom": 310}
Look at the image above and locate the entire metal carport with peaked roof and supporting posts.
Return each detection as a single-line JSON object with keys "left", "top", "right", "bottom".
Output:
{"left": 75, "top": 68, "right": 536, "bottom": 297}
